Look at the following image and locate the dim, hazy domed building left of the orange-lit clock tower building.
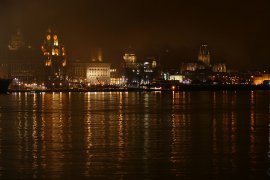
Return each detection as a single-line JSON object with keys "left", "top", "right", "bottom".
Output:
{"left": 0, "top": 29, "right": 43, "bottom": 84}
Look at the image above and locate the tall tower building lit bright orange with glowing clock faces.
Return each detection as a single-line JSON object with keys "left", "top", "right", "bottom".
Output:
{"left": 41, "top": 28, "right": 67, "bottom": 88}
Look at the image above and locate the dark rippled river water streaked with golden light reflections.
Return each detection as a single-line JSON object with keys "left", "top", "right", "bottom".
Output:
{"left": 0, "top": 91, "right": 270, "bottom": 179}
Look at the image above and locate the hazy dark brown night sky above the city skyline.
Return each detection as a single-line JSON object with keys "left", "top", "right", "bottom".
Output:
{"left": 0, "top": 0, "right": 270, "bottom": 69}
